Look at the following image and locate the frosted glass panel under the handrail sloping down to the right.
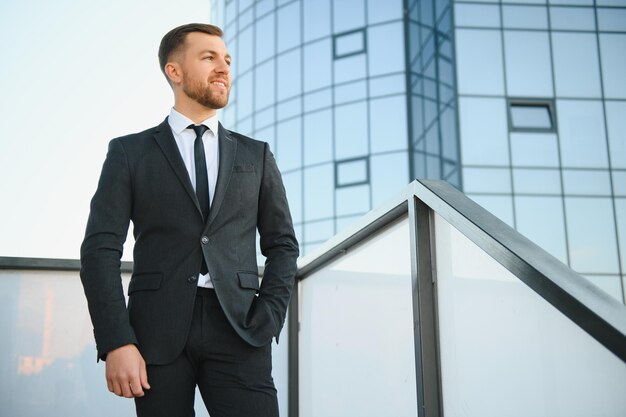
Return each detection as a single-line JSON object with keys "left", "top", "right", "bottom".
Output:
{"left": 435, "top": 215, "right": 626, "bottom": 417}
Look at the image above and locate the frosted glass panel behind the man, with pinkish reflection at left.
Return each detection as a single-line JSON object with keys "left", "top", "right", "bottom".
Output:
{"left": 0, "top": 270, "right": 289, "bottom": 417}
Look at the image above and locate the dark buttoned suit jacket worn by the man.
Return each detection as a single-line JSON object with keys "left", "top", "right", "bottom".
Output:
{"left": 80, "top": 119, "right": 298, "bottom": 364}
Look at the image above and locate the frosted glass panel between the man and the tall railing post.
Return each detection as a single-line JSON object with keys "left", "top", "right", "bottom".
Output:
{"left": 299, "top": 217, "right": 417, "bottom": 417}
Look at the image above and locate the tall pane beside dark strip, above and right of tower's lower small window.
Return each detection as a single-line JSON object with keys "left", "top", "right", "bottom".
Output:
{"left": 370, "top": 96, "right": 408, "bottom": 153}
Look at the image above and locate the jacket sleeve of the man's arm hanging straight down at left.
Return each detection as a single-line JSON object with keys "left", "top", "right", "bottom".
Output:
{"left": 80, "top": 139, "right": 137, "bottom": 360}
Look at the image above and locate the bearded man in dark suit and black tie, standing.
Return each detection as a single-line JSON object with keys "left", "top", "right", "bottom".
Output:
{"left": 81, "top": 24, "right": 298, "bottom": 417}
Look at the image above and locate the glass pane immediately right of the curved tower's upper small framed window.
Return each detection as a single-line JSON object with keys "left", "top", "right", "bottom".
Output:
{"left": 367, "top": 23, "right": 405, "bottom": 76}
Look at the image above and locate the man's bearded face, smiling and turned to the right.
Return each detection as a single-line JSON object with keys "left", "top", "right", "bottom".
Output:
{"left": 180, "top": 32, "right": 231, "bottom": 109}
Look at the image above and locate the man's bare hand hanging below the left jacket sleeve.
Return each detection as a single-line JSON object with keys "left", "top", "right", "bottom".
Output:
{"left": 106, "top": 344, "right": 150, "bottom": 398}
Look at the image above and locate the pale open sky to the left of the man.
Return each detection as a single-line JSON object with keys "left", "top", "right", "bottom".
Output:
{"left": 0, "top": 0, "right": 210, "bottom": 260}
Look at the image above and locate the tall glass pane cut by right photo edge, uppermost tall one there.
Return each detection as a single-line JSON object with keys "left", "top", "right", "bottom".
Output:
{"left": 600, "top": 33, "right": 626, "bottom": 98}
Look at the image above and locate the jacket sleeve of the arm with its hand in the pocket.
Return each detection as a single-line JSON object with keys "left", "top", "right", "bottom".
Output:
{"left": 257, "top": 144, "right": 299, "bottom": 339}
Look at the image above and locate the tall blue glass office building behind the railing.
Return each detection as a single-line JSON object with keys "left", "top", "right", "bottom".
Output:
{"left": 212, "top": 0, "right": 626, "bottom": 301}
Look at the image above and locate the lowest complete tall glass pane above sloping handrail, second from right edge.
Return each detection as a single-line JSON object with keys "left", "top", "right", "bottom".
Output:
{"left": 565, "top": 197, "right": 619, "bottom": 274}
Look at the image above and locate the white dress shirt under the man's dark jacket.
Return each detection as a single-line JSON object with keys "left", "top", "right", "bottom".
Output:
{"left": 167, "top": 108, "right": 219, "bottom": 288}
